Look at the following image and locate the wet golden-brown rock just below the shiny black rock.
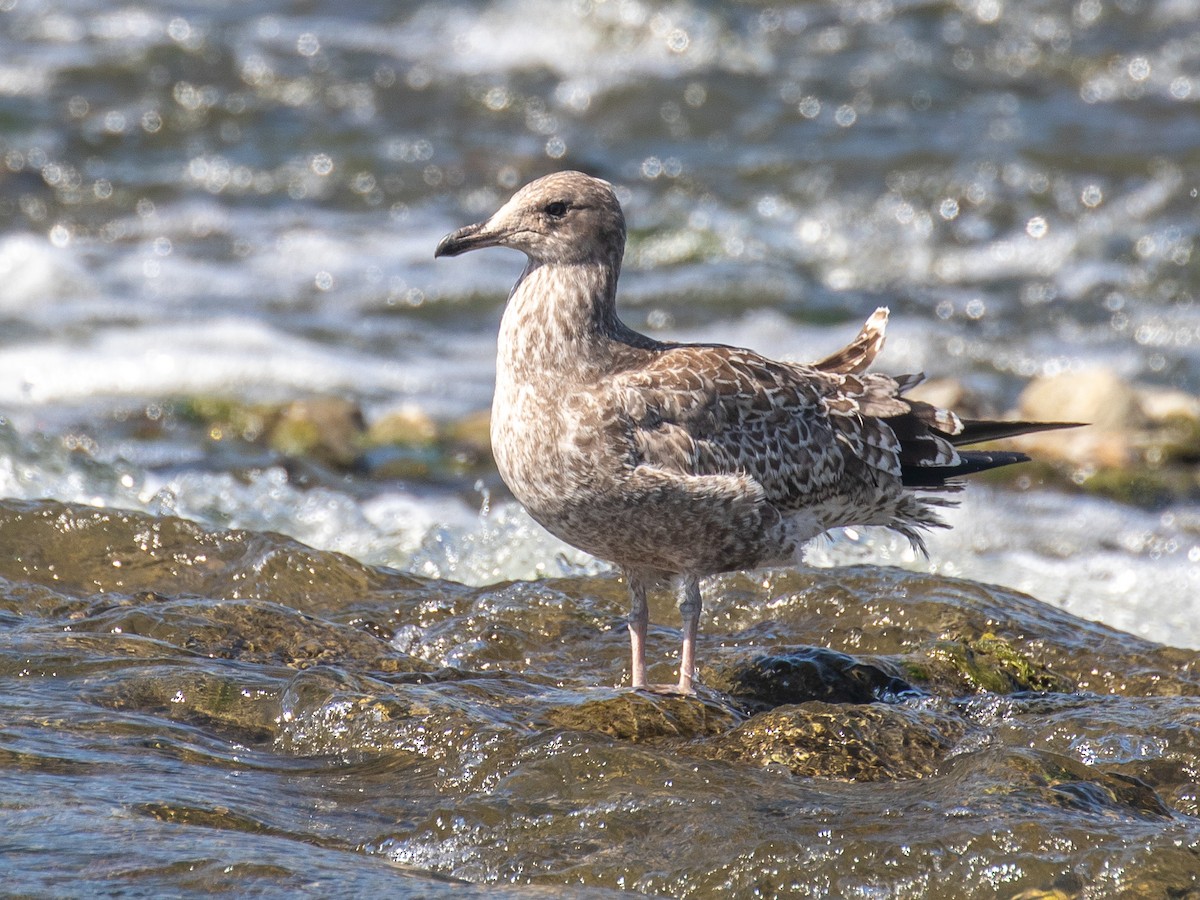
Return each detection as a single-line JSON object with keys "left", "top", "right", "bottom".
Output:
{"left": 706, "top": 702, "right": 966, "bottom": 781}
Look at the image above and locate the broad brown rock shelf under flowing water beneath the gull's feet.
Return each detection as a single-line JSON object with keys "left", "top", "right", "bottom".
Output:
{"left": 7, "top": 500, "right": 1200, "bottom": 900}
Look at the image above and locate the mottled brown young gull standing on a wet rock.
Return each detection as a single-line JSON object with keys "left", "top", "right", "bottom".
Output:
{"left": 434, "top": 172, "right": 1061, "bottom": 694}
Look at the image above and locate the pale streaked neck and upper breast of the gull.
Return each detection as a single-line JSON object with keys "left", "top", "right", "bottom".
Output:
{"left": 498, "top": 260, "right": 653, "bottom": 380}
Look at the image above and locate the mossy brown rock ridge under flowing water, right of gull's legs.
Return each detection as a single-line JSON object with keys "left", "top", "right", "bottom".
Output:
{"left": 702, "top": 566, "right": 1200, "bottom": 696}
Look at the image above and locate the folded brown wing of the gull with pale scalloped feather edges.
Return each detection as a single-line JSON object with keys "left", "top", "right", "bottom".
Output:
{"left": 617, "top": 310, "right": 979, "bottom": 512}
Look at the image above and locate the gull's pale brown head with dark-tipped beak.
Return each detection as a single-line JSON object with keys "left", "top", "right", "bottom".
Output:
{"left": 433, "top": 172, "right": 625, "bottom": 265}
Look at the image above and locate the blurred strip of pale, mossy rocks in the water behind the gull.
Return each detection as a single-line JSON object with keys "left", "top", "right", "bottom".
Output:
{"left": 159, "top": 368, "right": 1200, "bottom": 506}
